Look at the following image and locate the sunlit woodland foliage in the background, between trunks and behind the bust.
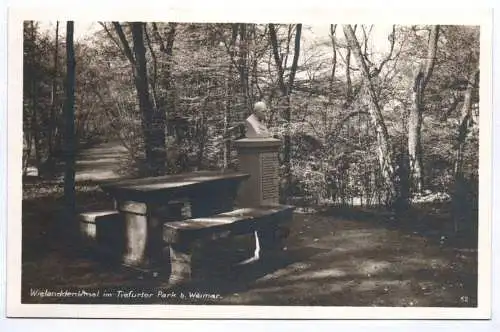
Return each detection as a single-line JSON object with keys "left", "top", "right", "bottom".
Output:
{"left": 23, "top": 22, "right": 479, "bottom": 228}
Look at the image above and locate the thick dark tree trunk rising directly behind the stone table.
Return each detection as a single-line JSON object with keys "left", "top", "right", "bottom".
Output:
{"left": 132, "top": 22, "right": 166, "bottom": 176}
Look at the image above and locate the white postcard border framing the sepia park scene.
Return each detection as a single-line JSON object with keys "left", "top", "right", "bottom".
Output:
{"left": 7, "top": 5, "right": 493, "bottom": 319}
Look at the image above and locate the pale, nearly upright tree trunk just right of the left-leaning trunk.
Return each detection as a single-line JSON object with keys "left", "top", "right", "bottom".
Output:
{"left": 408, "top": 25, "right": 439, "bottom": 192}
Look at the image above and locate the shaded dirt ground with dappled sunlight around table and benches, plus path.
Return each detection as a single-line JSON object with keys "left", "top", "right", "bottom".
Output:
{"left": 22, "top": 140, "right": 477, "bottom": 307}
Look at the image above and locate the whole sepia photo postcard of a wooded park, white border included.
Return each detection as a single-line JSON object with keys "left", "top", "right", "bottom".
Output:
{"left": 7, "top": 7, "right": 492, "bottom": 318}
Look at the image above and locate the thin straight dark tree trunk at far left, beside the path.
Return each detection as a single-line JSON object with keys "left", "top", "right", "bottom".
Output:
{"left": 64, "top": 21, "right": 76, "bottom": 231}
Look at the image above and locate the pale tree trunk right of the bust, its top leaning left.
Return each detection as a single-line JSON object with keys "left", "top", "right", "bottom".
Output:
{"left": 344, "top": 25, "right": 397, "bottom": 206}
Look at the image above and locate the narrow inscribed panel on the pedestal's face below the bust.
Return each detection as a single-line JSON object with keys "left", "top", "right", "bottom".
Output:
{"left": 260, "top": 152, "right": 279, "bottom": 203}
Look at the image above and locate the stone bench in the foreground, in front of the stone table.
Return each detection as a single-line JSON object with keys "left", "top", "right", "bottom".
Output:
{"left": 163, "top": 205, "right": 294, "bottom": 284}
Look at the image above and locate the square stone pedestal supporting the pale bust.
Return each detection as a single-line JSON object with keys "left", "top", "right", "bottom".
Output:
{"left": 235, "top": 137, "right": 281, "bottom": 207}
